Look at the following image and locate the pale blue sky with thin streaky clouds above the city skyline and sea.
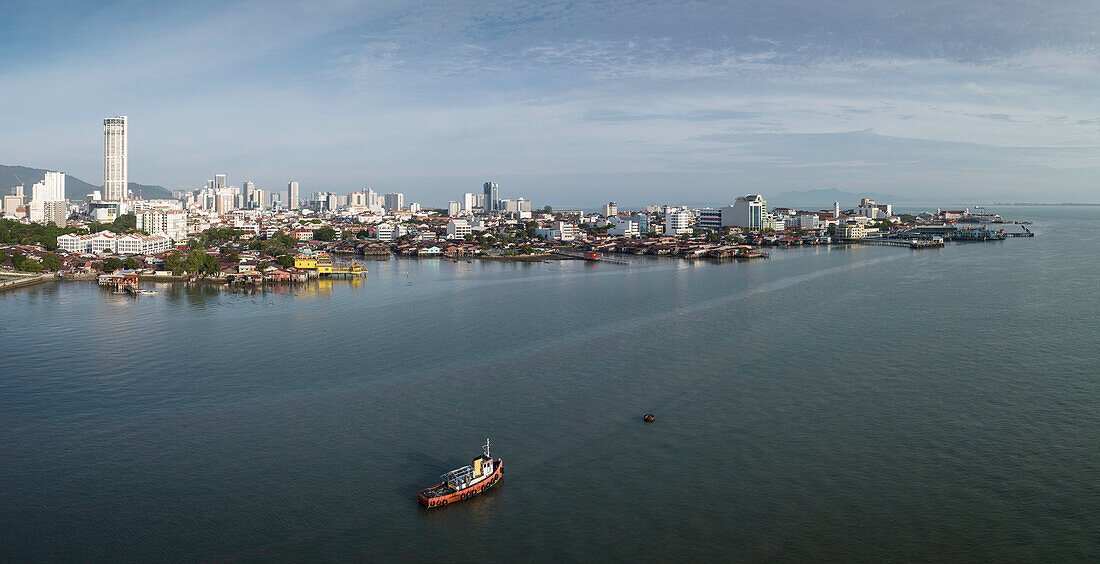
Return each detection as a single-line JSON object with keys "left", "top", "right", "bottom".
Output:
{"left": 0, "top": 0, "right": 1100, "bottom": 208}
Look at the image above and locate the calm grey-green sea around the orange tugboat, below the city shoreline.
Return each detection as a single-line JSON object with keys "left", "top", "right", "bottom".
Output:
{"left": 0, "top": 208, "right": 1100, "bottom": 562}
